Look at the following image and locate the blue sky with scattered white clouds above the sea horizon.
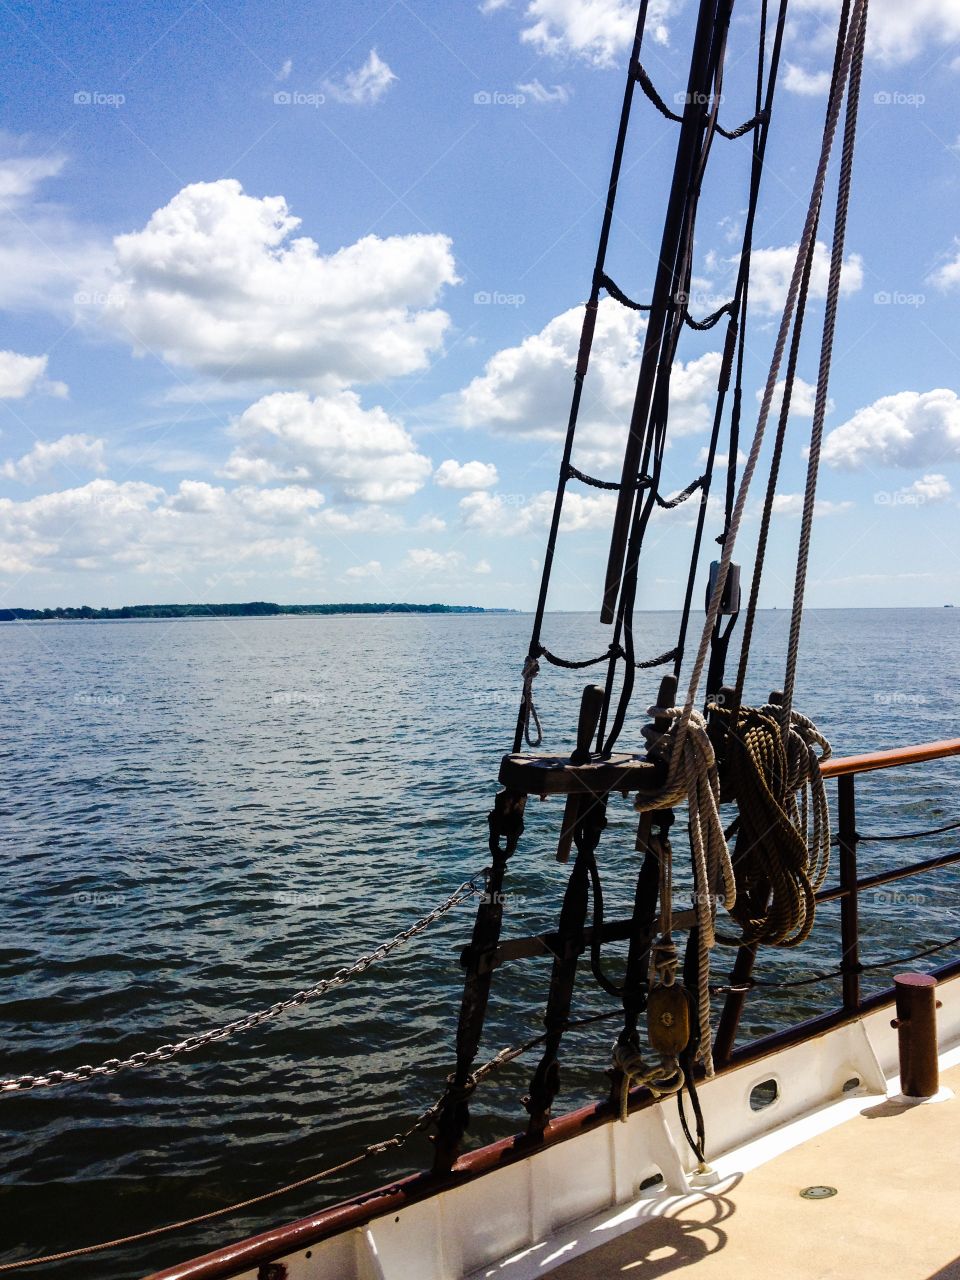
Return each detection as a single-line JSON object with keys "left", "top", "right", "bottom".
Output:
{"left": 0, "top": 0, "right": 960, "bottom": 609}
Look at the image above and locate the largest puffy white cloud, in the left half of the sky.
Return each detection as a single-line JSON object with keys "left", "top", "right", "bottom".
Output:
{"left": 100, "top": 178, "right": 457, "bottom": 389}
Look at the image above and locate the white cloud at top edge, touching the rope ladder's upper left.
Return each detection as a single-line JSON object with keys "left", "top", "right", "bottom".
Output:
{"left": 520, "top": 0, "right": 676, "bottom": 67}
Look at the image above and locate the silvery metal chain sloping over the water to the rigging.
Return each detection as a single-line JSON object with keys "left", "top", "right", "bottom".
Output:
{"left": 0, "top": 868, "right": 488, "bottom": 1093}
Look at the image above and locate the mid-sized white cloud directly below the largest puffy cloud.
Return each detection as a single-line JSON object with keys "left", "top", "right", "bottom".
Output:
{"left": 224, "top": 390, "right": 433, "bottom": 502}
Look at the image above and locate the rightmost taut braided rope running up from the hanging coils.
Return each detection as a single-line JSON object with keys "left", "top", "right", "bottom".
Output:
{"left": 782, "top": 0, "right": 868, "bottom": 727}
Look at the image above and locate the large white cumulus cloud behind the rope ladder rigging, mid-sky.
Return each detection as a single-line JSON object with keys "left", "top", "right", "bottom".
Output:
{"left": 454, "top": 298, "right": 721, "bottom": 466}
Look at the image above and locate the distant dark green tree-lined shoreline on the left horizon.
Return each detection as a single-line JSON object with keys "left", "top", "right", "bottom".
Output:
{"left": 0, "top": 600, "right": 518, "bottom": 622}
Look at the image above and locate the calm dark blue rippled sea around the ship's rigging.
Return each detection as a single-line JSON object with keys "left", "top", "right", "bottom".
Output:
{"left": 0, "top": 609, "right": 960, "bottom": 1280}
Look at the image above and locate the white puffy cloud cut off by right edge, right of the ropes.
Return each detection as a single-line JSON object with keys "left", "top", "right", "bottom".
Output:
{"left": 823, "top": 387, "right": 960, "bottom": 467}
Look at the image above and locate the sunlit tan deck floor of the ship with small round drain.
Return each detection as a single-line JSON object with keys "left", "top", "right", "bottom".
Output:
{"left": 549, "top": 1068, "right": 960, "bottom": 1280}
